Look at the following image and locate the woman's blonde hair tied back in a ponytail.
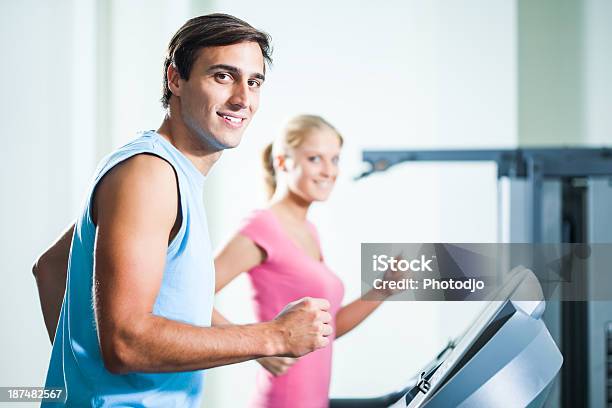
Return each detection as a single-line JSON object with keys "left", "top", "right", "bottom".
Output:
{"left": 262, "top": 115, "right": 344, "bottom": 198}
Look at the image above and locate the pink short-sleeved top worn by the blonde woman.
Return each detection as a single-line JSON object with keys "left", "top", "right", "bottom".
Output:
{"left": 240, "top": 209, "right": 344, "bottom": 408}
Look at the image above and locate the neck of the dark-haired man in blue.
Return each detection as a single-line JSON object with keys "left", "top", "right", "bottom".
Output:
{"left": 157, "top": 113, "right": 222, "bottom": 176}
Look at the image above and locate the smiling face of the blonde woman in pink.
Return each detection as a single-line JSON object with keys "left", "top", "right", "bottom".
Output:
{"left": 285, "top": 127, "right": 341, "bottom": 202}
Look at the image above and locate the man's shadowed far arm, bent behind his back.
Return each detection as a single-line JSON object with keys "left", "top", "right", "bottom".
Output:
{"left": 32, "top": 224, "right": 74, "bottom": 344}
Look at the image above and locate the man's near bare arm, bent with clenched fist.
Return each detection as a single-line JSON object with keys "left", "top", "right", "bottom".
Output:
{"left": 94, "top": 155, "right": 331, "bottom": 373}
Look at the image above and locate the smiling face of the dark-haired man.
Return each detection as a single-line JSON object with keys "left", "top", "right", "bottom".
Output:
{"left": 178, "top": 42, "right": 264, "bottom": 151}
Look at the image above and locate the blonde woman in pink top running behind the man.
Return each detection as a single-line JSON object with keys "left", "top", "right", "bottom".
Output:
{"left": 213, "top": 115, "right": 391, "bottom": 408}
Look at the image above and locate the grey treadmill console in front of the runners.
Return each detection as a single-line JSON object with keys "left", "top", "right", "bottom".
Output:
{"left": 330, "top": 266, "right": 563, "bottom": 408}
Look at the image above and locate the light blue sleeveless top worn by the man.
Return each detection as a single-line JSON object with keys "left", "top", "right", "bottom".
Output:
{"left": 43, "top": 131, "right": 215, "bottom": 407}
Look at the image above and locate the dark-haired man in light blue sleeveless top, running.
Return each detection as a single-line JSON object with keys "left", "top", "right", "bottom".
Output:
{"left": 33, "top": 14, "right": 332, "bottom": 407}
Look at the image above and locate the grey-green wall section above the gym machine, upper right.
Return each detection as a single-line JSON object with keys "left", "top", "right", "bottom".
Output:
{"left": 517, "top": 0, "right": 585, "bottom": 146}
